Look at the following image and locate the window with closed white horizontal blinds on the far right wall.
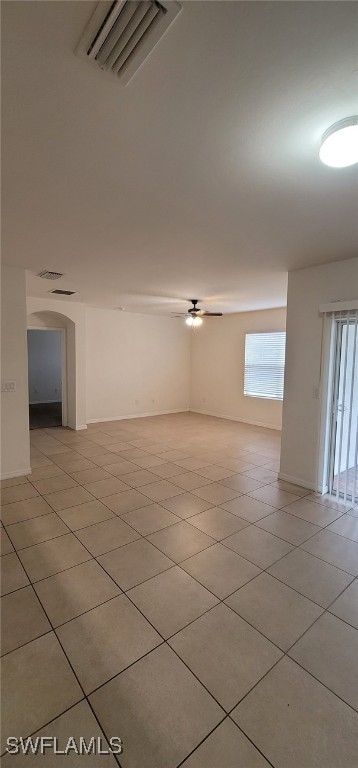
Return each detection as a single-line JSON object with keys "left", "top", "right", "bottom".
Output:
{"left": 244, "top": 331, "right": 286, "bottom": 400}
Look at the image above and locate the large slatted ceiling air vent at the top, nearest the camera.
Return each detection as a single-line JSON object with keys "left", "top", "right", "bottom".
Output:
{"left": 75, "top": 0, "right": 181, "bottom": 85}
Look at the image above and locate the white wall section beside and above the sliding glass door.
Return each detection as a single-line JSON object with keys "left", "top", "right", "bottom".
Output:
{"left": 280, "top": 258, "right": 358, "bottom": 488}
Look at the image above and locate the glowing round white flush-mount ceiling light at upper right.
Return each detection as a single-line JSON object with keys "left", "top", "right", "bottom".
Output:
{"left": 319, "top": 115, "right": 358, "bottom": 168}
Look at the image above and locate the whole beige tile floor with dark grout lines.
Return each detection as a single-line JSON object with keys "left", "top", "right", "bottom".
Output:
{"left": 1, "top": 414, "right": 358, "bottom": 768}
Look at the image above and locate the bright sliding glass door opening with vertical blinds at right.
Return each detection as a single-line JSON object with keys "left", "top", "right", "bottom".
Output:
{"left": 328, "top": 311, "right": 358, "bottom": 505}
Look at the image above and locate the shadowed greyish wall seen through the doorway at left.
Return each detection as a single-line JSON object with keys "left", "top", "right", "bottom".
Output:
{"left": 27, "top": 330, "right": 62, "bottom": 404}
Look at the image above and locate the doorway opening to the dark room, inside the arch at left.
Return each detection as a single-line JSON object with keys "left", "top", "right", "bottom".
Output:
{"left": 27, "top": 328, "right": 67, "bottom": 429}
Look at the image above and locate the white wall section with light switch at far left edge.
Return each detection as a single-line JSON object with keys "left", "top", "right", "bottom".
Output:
{"left": 1, "top": 265, "right": 30, "bottom": 478}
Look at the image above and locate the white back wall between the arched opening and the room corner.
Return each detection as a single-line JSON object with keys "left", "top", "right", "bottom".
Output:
{"left": 86, "top": 307, "right": 190, "bottom": 422}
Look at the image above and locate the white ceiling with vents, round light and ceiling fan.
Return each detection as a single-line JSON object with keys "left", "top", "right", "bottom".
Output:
{"left": 2, "top": 0, "right": 358, "bottom": 312}
